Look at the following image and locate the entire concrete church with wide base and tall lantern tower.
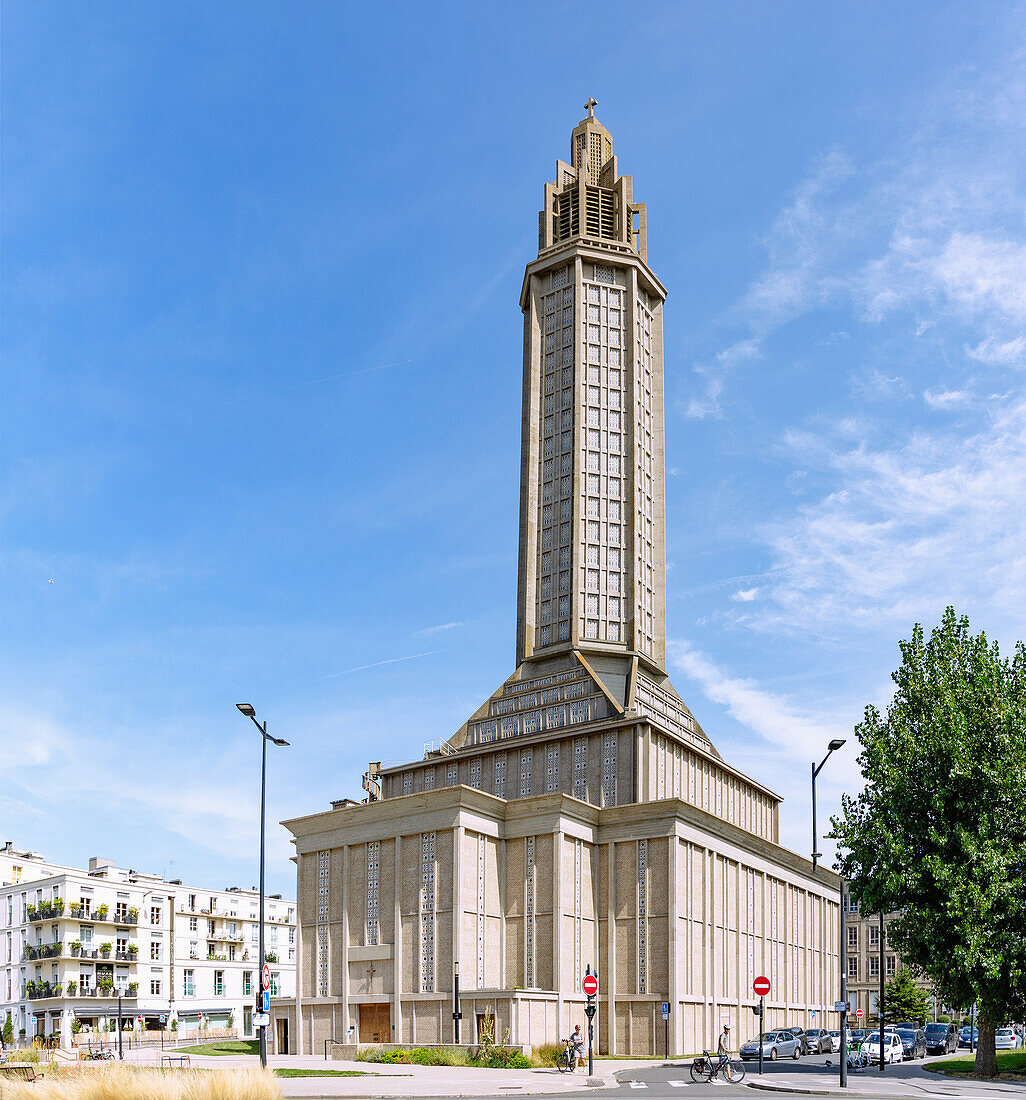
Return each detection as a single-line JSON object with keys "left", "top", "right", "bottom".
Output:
{"left": 274, "top": 109, "right": 840, "bottom": 1055}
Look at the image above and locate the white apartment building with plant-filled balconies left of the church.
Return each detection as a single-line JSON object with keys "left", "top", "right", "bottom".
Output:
{"left": 0, "top": 843, "right": 296, "bottom": 1046}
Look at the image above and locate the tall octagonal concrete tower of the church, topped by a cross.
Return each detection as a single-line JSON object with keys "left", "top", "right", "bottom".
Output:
{"left": 517, "top": 100, "right": 666, "bottom": 677}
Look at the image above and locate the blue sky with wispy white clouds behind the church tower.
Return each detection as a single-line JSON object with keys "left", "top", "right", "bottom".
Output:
{"left": 0, "top": 0, "right": 1026, "bottom": 892}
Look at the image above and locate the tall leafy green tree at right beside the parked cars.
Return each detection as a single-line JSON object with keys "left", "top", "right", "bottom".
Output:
{"left": 832, "top": 607, "right": 1026, "bottom": 1077}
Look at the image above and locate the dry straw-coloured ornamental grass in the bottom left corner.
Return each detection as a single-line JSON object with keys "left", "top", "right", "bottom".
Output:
{"left": 0, "top": 1066, "right": 282, "bottom": 1100}
